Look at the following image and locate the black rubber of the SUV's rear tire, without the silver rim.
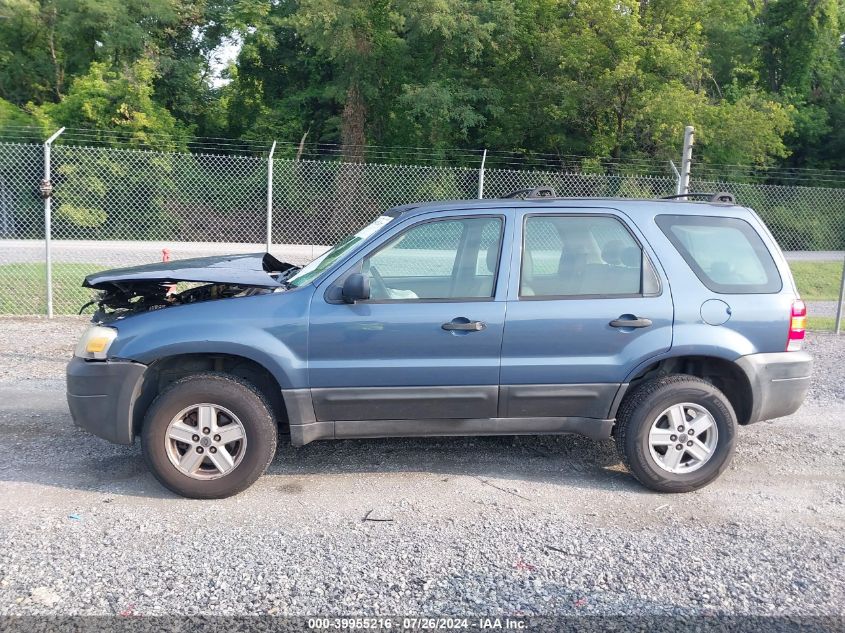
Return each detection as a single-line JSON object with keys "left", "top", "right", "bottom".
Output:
{"left": 616, "top": 374, "right": 737, "bottom": 492}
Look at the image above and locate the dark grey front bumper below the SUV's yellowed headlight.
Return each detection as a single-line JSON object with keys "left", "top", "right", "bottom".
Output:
{"left": 67, "top": 357, "right": 147, "bottom": 444}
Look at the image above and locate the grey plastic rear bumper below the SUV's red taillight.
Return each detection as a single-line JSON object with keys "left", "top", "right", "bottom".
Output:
{"left": 737, "top": 352, "right": 813, "bottom": 424}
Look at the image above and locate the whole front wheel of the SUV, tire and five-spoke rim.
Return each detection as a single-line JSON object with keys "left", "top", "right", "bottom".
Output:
{"left": 141, "top": 372, "right": 278, "bottom": 499}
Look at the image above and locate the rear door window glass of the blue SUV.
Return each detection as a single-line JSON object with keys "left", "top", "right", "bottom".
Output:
{"left": 519, "top": 215, "right": 659, "bottom": 298}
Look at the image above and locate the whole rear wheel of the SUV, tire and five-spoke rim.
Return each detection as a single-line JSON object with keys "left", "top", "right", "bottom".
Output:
{"left": 616, "top": 374, "right": 737, "bottom": 492}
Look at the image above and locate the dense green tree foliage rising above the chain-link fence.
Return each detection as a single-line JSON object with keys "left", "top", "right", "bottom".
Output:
{"left": 0, "top": 0, "right": 845, "bottom": 169}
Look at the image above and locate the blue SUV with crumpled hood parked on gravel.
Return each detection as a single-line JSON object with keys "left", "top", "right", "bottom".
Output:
{"left": 67, "top": 189, "right": 812, "bottom": 498}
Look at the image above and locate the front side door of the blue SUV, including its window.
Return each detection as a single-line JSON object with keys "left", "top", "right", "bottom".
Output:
{"left": 308, "top": 214, "right": 506, "bottom": 424}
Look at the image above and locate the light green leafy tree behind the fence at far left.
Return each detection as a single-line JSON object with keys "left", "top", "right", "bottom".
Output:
{"left": 35, "top": 60, "right": 185, "bottom": 239}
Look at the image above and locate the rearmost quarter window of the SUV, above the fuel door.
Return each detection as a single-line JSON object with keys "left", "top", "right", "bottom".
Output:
{"left": 656, "top": 215, "right": 783, "bottom": 294}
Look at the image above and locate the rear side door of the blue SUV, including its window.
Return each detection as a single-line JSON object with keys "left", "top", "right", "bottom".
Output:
{"left": 499, "top": 209, "right": 673, "bottom": 419}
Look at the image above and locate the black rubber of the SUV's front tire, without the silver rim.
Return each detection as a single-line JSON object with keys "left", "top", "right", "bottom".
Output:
{"left": 141, "top": 372, "right": 278, "bottom": 499}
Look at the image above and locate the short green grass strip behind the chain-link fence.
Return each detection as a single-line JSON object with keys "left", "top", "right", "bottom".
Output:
{"left": 0, "top": 261, "right": 842, "bottom": 330}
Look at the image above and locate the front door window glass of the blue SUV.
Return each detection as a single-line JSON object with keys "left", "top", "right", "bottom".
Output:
{"left": 356, "top": 217, "right": 503, "bottom": 301}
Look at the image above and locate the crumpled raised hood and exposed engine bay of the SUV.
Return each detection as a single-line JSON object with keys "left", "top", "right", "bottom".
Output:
{"left": 80, "top": 253, "right": 299, "bottom": 322}
